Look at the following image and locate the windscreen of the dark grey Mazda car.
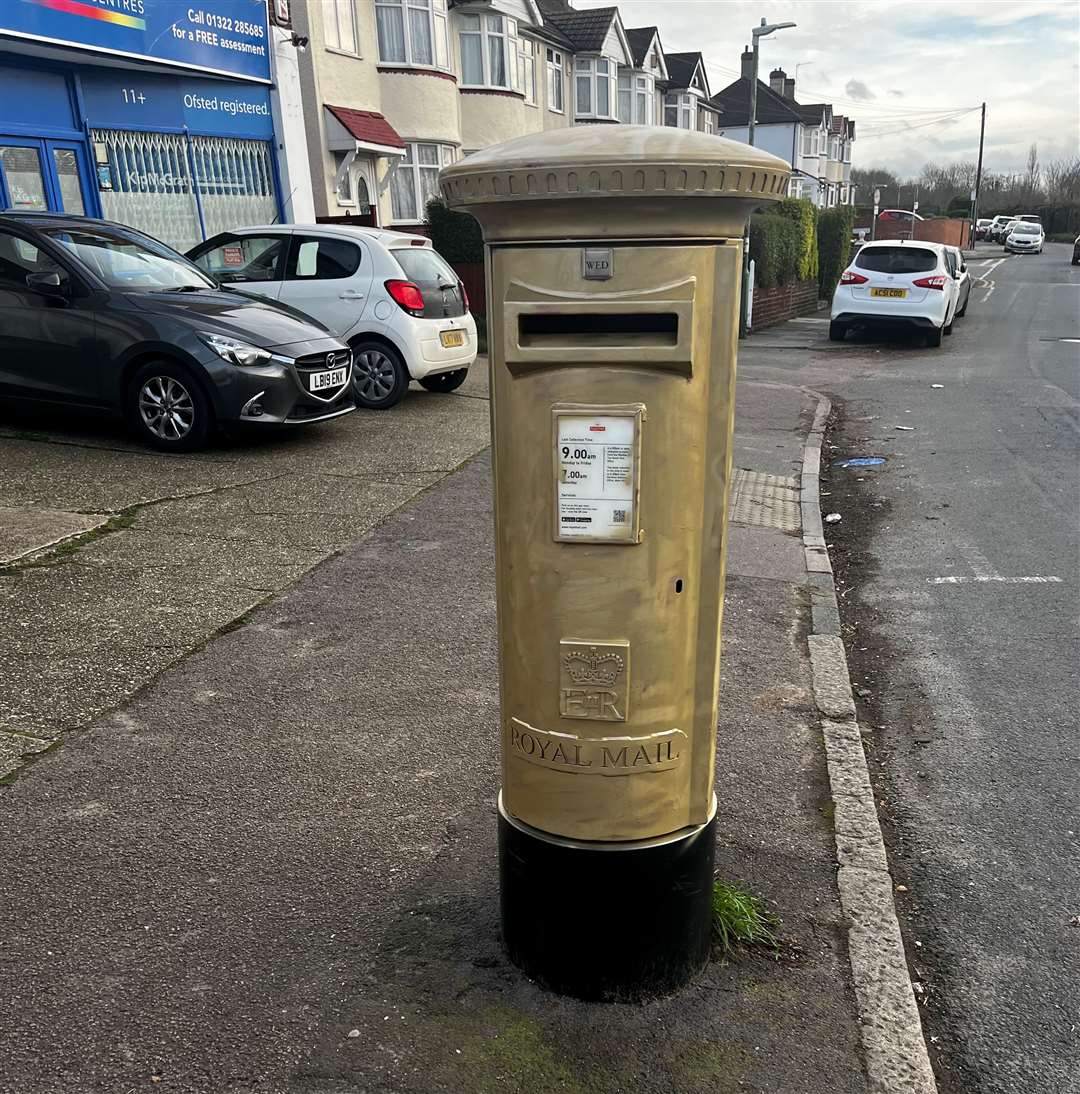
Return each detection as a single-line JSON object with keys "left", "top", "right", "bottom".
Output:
{"left": 44, "top": 226, "right": 217, "bottom": 292}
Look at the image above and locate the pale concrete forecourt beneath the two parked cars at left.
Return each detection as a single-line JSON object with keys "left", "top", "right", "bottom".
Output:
{"left": 0, "top": 360, "right": 488, "bottom": 777}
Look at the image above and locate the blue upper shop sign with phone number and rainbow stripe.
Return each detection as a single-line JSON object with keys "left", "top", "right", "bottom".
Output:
{"left": 0, "top": 0, "right": 271, "bottom": 83}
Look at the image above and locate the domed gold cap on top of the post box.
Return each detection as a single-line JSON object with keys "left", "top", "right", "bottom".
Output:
{"left": 439, "top": 125, "right": 791, "bottom": 211}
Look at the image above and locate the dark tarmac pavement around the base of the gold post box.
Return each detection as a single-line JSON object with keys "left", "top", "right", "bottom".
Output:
{"left": 0, "top": 380, "right": 868, "bottom": 1094}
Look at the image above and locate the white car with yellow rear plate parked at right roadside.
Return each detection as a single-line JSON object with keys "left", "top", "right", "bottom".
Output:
{"left": 828, "top": 240, "right": 959, "bottom": 346}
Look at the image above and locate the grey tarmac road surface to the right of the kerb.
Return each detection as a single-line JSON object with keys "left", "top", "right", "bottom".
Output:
{"left": 740, "top": 244, "right": 1080, "bottom": 1094}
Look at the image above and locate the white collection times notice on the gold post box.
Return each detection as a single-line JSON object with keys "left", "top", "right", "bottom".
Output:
{"left": 555, "top": 412, "right": 639, "bottom": 543}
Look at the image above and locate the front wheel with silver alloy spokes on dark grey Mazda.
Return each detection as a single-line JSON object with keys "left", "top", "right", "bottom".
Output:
{"left": 127, "top": 361, "right": 213, "bottom": 452}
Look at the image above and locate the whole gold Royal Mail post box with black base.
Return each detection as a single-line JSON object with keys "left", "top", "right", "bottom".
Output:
{"left": 440, "top": 125, "right": 790, "bottom": 999}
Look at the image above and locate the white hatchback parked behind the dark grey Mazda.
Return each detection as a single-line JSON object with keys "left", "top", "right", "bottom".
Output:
{"left": 187, "top": 224, "right": 476, "bottom": 410}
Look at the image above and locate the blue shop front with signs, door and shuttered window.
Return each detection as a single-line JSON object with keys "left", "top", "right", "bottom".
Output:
{"left": 0, "top": 0, "right": 280, "bottom": 251}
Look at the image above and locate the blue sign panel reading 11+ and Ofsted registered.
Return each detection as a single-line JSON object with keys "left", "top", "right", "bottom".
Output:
{"left": 81, "top": 69, "right": 274, "bottom": 140}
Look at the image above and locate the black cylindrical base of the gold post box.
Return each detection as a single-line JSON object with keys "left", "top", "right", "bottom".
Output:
{"left": 499, "top": 803, "right": 717, "bottom": 1002}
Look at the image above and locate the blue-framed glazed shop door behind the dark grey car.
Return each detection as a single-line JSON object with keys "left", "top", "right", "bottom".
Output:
{"left": 0, "top": 135, "right": 94, "bottom": 217}
